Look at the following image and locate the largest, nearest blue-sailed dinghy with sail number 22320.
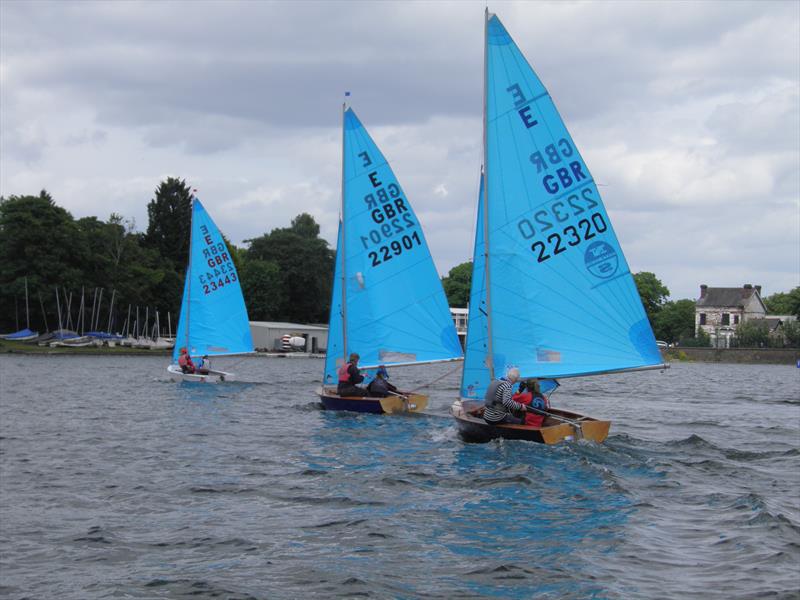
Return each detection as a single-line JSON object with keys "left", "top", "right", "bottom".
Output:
{"left": 452, "top": 10, "right": 667, "bottom": 443}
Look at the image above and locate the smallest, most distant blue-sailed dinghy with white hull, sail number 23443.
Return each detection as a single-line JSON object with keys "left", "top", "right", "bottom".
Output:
{"left": 167, "top": 198, "right": 254, "bottom": 383}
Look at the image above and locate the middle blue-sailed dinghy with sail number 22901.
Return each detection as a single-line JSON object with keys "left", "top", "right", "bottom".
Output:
{"left": 318, "top": 104, "right": 463, "bottom": 413}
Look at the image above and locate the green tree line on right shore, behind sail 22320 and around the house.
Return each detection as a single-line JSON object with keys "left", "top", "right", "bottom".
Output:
{"left": 442, "top": 261, "right": 800, "bottom": 346}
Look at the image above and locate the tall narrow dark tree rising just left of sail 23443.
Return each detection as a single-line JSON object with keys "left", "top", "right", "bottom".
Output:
{"left": 145, "top": 177, "right": 192, "bottom": 269}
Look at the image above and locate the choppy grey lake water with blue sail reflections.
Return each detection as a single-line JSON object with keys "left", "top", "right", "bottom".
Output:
{"left": 0, "top": 355, "right": 800, "bottom": 599}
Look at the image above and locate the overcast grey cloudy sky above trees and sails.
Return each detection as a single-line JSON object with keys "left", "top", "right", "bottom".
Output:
{"left": 0, "top": 0, "right": 800, "bottom": 299}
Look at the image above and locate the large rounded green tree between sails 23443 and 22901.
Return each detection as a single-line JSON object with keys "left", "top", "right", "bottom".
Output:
{"left": 246, "top": 213, "right": 334, "bottom": 323}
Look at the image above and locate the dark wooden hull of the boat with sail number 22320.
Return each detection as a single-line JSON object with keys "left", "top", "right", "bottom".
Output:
{"left": 450, "top": 400, "right": 611, "bottom": 444}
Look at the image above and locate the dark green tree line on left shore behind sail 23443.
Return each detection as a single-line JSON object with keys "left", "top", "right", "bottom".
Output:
{"left": 0, "top": 178, "right": 334, "bottom": 332}
